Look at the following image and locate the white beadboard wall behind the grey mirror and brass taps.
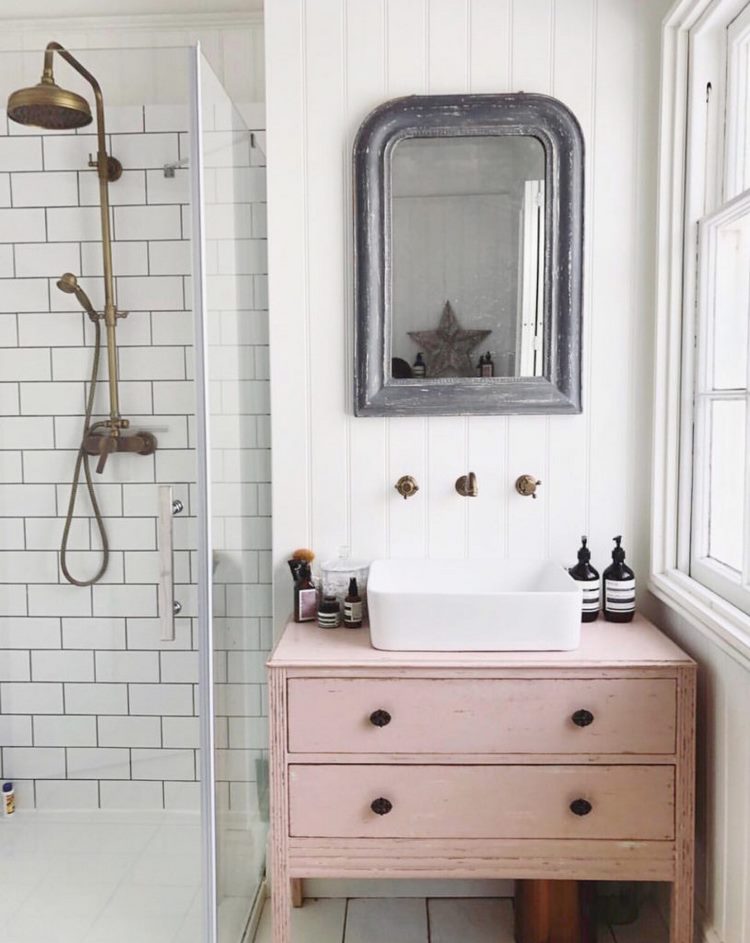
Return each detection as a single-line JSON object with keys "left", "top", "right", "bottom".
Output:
{"left": 265, "top": 0, "right": 668, "bottom": 627}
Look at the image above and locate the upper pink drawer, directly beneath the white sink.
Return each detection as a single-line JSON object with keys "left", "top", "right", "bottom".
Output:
{"left": 288, "top": 678, "right": 676, "bottom": 754}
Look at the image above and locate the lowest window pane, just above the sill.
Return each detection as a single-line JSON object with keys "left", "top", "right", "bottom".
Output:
{"left": 708, "top": 400, "right": 746, "bottom": 572}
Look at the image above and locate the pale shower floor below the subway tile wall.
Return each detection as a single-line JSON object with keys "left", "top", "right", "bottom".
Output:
{"left": 0, "top": 812, "right": 257, "bottom": 943}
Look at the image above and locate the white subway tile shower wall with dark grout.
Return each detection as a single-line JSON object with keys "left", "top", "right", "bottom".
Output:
{"left": 0, "top": 105, "right": 271, "bottom": 811}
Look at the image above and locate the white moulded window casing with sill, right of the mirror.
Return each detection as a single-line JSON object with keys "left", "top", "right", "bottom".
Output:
{"left": 649, "top": 0, "right": 750, "bottom": 665}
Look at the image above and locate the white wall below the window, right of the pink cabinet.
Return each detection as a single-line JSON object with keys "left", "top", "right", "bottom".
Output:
{"left": 647, "top": 595, "right": 750, "bottom": 943}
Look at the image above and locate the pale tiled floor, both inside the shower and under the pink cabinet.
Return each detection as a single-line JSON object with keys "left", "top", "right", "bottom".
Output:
{"left": 0, "top": 812, "right": 667, "bottom": 943}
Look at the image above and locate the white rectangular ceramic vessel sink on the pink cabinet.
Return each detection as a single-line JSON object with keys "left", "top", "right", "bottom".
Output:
{"left": 367, "top": 559, "right": 581, "bottom": 652}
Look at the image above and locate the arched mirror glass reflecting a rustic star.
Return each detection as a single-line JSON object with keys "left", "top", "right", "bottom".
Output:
{"left": 390, "top": 134, "right": 549, "bottom": 381}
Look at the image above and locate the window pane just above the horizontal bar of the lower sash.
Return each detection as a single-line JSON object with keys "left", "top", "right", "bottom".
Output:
{"left": 712, "top": 213, "right": 750, "bottom": 390}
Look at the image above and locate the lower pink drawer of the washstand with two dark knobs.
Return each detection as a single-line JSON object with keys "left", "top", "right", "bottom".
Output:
{"left": 289, "top": 765, "right": 674, "bottom": 841}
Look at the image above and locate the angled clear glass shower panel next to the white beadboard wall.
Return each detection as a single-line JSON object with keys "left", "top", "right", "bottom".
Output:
{"left": 191, "top": 49, "right": 271, "bottom": 943}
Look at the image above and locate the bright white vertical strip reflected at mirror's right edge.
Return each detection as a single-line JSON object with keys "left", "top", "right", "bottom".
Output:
{"left": 516, "top": 180, "right": 544, "bottom": 377}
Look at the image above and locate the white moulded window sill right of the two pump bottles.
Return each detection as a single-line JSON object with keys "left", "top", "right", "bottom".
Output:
{"left": 649, "top": 570, "right": 750, "bottom": 668}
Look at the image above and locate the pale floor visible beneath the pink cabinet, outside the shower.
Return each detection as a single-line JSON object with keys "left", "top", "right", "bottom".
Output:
{"left": 255, "top": 898, "right": 668, "bottom": 943}
